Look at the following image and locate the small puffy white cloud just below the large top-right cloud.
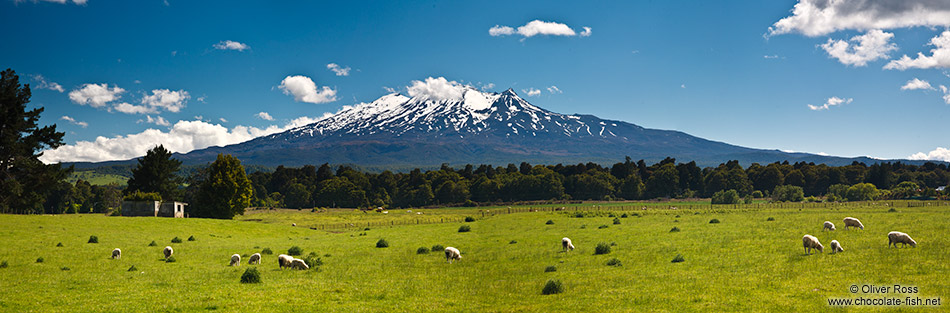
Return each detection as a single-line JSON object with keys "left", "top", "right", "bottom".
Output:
{"left": 821, "top": 29, "right": 897, "bottom": 66}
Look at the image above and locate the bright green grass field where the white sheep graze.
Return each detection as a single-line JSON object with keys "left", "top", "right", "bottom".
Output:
{"left": 0, "top": 204, "right": 950, "bottom": 312}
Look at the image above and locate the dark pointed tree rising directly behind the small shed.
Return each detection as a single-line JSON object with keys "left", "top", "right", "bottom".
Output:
{"left": 125, "top": 145, "right": 182, "bottom": 201}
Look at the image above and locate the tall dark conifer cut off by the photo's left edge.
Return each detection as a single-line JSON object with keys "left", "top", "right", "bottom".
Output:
{"left": 0, "top": 69, "right": 72, "bottom": 213}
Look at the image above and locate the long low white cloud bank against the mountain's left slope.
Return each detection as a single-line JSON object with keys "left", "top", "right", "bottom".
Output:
{"left": 40, "top": 116, "right": 328, "bottom": 163}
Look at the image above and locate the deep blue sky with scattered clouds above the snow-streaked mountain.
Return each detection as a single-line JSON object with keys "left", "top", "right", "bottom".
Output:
{"left": 0, "top": 0, "right": 950, "bottom": 161}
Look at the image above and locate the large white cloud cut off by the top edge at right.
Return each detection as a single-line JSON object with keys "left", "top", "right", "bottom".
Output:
{"left": 767, "top": 0, "right": 950, "bottom": 37}
